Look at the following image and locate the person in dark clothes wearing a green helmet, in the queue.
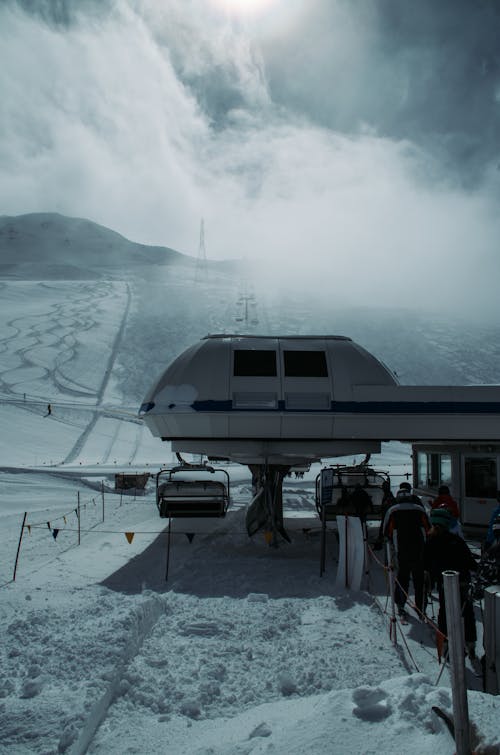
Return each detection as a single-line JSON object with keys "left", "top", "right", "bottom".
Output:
{"left": 423, "top": 509, "right": 478, "bottom": 658}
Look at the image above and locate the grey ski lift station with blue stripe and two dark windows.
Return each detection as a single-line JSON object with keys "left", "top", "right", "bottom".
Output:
{"left": 140, "top": 335, "right": 500, "bottom": 531}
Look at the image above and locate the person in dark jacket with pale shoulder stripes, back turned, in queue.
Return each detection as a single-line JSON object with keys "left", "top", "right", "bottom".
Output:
{"left": 383, "top": 482, "right": 430, "bottom": 617}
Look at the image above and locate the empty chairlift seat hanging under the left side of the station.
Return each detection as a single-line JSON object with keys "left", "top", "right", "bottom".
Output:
{"left": 156, "top": 465, "right": 229, "bottom": 518}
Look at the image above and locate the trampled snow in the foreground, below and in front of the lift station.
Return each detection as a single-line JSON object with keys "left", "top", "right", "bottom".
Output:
{"left": 0, "top": 468, "right": 500, "bottom": 755}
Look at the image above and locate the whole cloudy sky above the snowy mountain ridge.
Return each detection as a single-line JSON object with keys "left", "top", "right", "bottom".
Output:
{"left": 0, "top": 0, "right": 500, "bottom": 306}
